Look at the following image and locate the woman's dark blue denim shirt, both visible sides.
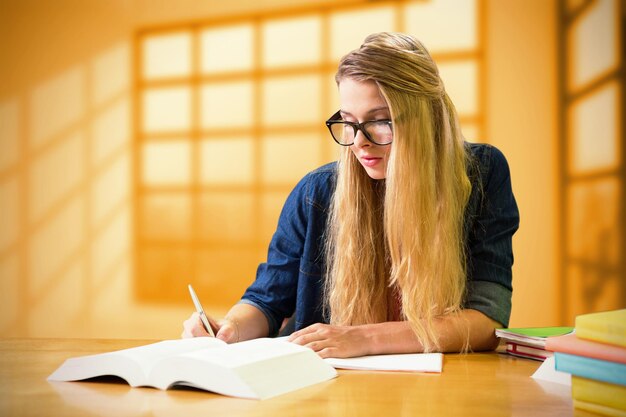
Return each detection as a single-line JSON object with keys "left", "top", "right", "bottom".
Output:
{"left": 240, "top": 144, "right": 519, "bottom": 336}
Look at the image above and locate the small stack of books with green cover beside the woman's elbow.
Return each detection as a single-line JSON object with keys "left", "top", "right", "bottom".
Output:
{"left": 496, "top": 327, "right": 574, "bottom": 361}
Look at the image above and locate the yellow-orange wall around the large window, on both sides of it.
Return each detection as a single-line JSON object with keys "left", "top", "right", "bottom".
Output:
{"left": 0, "top": 0, "right": 624, "bottom": 338}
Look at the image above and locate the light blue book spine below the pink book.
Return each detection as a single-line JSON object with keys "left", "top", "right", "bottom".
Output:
{"left": 554, "top": 352, "right": 626, "bottom": 385}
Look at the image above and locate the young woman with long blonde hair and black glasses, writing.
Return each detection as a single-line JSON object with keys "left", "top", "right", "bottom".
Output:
{"left": 183, "top": 33, "right": 519, "bottom": 357}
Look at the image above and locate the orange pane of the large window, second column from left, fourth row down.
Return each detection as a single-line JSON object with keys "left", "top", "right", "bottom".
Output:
{"left": 200, "top": 192, "right": 255, "bottom": 243}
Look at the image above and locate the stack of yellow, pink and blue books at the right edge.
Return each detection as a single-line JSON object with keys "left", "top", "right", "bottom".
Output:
{"left": 546, "top": 309, "right": 626, "bottom": 417}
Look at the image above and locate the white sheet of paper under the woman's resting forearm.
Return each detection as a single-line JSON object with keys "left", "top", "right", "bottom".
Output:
{"left": 324, "top": 353, "right": 443, "bottom": 373}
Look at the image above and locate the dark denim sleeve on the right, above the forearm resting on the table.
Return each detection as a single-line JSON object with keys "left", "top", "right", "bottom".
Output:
{"left": 465, "top": 146, "right": 519, "bottom": 326}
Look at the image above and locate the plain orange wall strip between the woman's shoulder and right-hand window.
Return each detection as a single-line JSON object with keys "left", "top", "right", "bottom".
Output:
{"left": 487, "top": 0, "right": 561, "bottom": 326}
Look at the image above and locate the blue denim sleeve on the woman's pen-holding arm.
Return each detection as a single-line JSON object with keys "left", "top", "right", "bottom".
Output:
{"left": 240, "top": 171, "right": 309, "bottom": 336}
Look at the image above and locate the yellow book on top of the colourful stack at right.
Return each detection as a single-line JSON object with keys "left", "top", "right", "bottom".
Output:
{"left": 576, "top": 309, "right": 626, "bottom": 346}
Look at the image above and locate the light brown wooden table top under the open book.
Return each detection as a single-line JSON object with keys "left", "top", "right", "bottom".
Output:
{"left": 0, "top": 339, "right": 593, "bottom": 417}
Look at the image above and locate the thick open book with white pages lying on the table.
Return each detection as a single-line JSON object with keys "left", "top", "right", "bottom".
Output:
{"left": 48, "top": 337, "right": 337, "bottom": 399}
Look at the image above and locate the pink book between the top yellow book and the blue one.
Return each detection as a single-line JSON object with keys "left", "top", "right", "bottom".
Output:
{"left": 546, "top": 334, "right": 626, "bottom": 363}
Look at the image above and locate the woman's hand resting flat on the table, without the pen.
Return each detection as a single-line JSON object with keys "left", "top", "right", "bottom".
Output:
{"left": 288, "top": 323, "right": 371, "bottom": 358}
